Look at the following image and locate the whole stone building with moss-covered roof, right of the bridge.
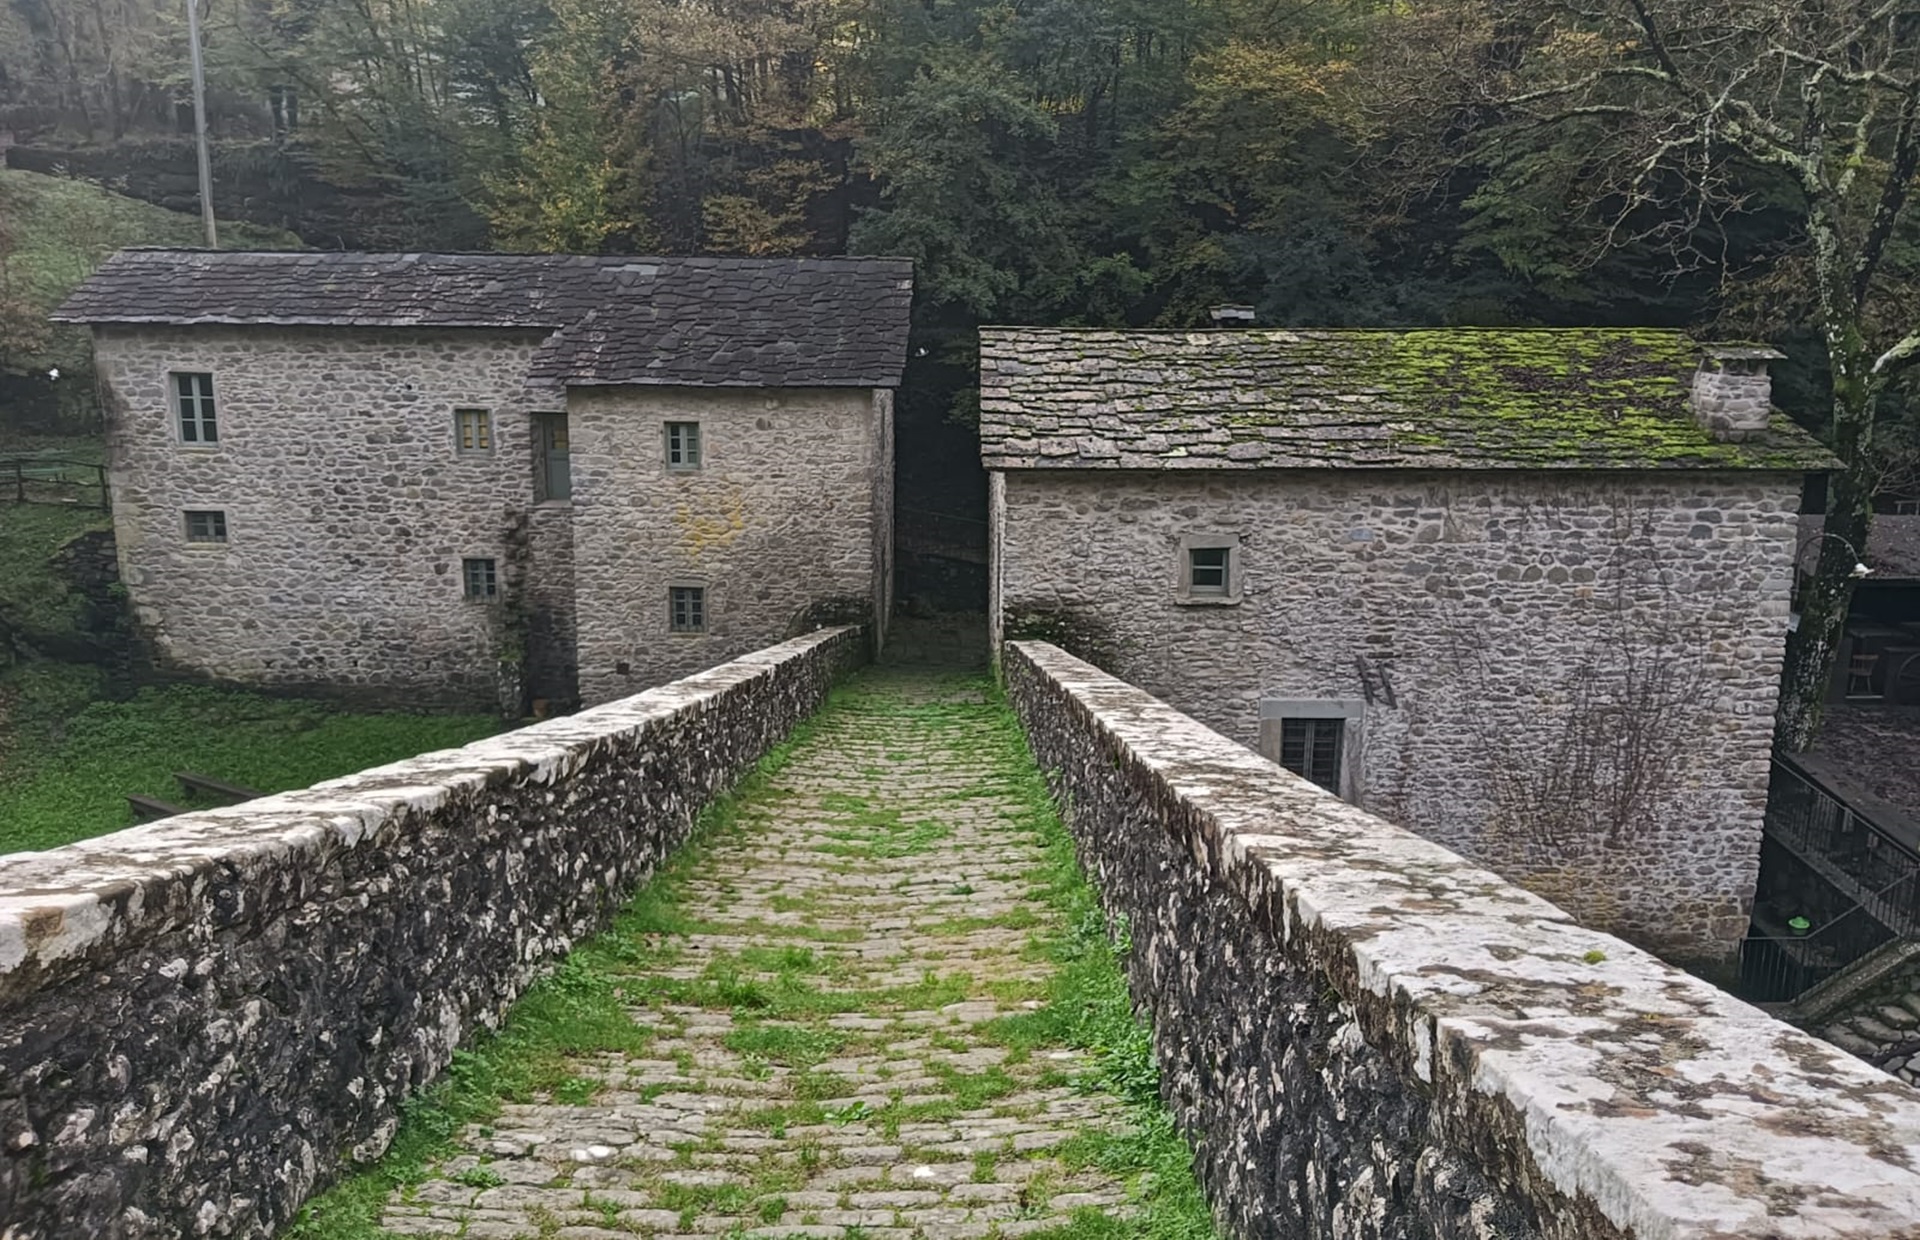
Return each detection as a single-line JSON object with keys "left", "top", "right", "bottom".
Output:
{"left": 981, "top": 328, "right": 1830, "bottom": 960}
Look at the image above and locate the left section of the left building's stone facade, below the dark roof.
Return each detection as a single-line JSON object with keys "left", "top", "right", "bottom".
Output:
{"left": 94, "top": 326, "right": 566, "bottom": 708}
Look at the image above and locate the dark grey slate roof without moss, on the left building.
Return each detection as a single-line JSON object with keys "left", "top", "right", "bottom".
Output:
{"left": 54, "top": 250, "right": 914, "bottom": 388}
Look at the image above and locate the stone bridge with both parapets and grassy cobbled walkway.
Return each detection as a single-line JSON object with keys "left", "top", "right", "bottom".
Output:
{"left": 0, "top": 630, "right": 1920, "bottom": 1240}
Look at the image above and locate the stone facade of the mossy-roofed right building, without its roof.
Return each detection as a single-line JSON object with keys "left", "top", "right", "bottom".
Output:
{"left": 993, "top": 470, "right": 1799, "bottom": 960}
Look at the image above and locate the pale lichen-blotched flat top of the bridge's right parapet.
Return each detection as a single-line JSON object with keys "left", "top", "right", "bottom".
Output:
{"left": 1014, "top": 641, "right": 1920, "bottom": 1240}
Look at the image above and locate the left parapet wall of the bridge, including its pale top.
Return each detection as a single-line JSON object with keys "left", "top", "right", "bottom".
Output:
{"left": 0, "top": 628, "right": 864, "bottom": 1240}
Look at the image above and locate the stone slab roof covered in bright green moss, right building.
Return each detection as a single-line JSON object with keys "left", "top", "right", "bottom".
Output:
{"left": 979, "top": 328, "right": 1834, "bottom": 470}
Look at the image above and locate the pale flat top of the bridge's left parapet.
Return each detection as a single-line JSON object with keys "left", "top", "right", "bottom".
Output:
{"left": 0, "top": 626, "right": 851, "bottom": 985}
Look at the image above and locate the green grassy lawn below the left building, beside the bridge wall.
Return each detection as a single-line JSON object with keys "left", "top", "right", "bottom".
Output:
{"left": 0, "top": 679, "right": 501, "bottom": 852}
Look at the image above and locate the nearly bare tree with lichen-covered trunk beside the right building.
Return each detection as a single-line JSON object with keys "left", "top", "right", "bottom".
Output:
{"left": 1375, "top": 0, "right": 1920, "bottom": 749}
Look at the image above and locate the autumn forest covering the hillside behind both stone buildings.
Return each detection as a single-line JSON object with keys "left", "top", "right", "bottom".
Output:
{"left": 0, "top": 0, "right": 1920, "bottom": 737}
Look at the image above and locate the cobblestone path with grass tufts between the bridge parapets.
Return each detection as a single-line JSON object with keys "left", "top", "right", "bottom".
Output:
{"left": 382, "top": 670, "right": 1131, "bottom": 1240}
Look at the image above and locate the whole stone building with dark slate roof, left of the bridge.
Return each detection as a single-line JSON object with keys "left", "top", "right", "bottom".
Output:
{"left": 56, "top": 250, "right": 912, "bottom": 710}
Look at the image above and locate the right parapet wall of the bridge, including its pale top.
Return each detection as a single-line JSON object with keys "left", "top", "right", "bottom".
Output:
{"left": 1004, "top": 643, "right": 1920, "bottom": 1240}
